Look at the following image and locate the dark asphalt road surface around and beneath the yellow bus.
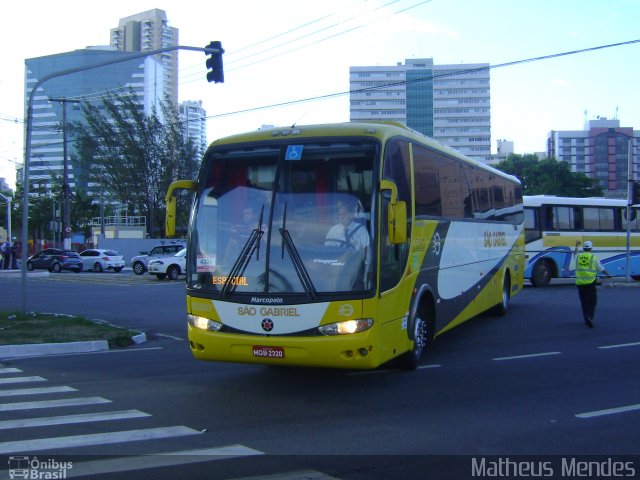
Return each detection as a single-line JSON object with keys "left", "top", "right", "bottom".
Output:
{"left": 0, "top": 273, "right": 640, "bottom": 480}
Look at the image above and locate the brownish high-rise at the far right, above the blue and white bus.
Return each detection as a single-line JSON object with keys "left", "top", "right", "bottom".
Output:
{"left": 547, "top": 118, "right": 640, "bottom": 198}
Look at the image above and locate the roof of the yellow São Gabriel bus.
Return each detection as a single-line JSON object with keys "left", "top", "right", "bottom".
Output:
{"left": 210, "top": 121, "right": 520, "bottom": 184}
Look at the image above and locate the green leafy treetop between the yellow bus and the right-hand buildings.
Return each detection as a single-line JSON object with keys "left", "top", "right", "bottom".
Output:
{"left": 496, "top": 153, "right": 603, "bottom": 197}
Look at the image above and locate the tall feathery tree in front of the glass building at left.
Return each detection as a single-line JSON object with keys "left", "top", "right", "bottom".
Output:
{"left": 73, "top": 92, "right": 198, "bottom": 235}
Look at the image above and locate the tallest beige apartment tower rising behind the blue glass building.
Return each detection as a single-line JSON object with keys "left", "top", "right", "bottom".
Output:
{"left": 111, "top": 8, "right": 179, "bottom": 107}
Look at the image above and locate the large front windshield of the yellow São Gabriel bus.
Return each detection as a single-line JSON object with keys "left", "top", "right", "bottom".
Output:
{"left": 187, "top": 139, "right": 380, "bottom": 300}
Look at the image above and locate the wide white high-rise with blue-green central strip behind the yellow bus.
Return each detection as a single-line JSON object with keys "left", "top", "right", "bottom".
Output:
{"left": 349, "top": 58, "right": 491, "bottom": 162}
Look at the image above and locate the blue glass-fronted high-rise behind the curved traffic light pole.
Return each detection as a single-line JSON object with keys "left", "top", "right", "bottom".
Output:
{"left": 24, "top": 47, "right": 164, "bottom": 194}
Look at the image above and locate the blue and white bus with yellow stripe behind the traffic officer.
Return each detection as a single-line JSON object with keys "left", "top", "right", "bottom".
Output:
{"left": 524, "top": 195, "right": 640, "bottom": 287}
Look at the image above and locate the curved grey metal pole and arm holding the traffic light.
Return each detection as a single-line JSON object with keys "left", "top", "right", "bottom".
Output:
{"left": 20, "top": 45, "right": 222, "bottom": 313}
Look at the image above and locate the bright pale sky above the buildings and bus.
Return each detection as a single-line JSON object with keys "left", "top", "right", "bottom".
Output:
{"left": 0, "top": 0, "right": 640, "bottom": 189}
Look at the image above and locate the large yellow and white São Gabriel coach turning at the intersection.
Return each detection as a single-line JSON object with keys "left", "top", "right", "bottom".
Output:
{"left": 166, "top": 122, "right": 524, "bottom": 369}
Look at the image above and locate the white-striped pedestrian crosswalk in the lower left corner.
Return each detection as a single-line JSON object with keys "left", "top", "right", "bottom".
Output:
{"left": 0, "top": 364, "right": 263, "bottom": 478}
